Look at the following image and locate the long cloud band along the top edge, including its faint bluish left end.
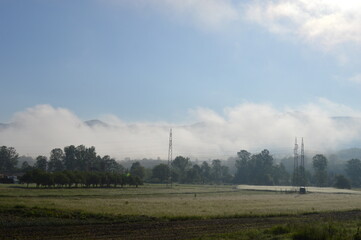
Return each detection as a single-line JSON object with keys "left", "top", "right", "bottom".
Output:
{"left": 107, "top": 0, "right": 361, "bottom": 50}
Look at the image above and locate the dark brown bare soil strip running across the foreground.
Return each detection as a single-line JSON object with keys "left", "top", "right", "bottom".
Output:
{"left": 0, "top": 210, "right": 361, "bottom": 240}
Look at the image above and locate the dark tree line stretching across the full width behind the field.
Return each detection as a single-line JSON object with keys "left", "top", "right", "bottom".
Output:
{"left": 0, "top": 145, "right": 361, "bottom": 188}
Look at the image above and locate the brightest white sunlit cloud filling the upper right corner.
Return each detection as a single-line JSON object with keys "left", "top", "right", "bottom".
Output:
{"left": 246, "top": 0, "right": 361, "bottom": 49}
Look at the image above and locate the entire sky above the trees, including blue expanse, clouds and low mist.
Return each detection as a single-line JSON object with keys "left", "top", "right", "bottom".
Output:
{"left": 0, "top": 0, "right": 361, "bottom": 158}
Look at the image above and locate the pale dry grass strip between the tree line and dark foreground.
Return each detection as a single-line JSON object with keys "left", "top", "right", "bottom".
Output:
{"left": 0, "top": 185, "right": 361, "bottom": 217}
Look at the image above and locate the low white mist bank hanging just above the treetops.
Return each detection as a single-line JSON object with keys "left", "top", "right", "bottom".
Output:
{"left": 0, "top": 99, "right": 361, "bottom": 160}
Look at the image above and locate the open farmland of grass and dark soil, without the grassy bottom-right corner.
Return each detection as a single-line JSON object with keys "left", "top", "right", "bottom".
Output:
{"left": 0, "top": 185, "right": 361, "bottom": 239}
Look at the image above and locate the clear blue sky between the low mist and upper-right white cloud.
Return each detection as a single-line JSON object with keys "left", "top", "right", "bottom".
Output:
{"left": 0, "top": 0, "right": 361, "bottom": 122}
